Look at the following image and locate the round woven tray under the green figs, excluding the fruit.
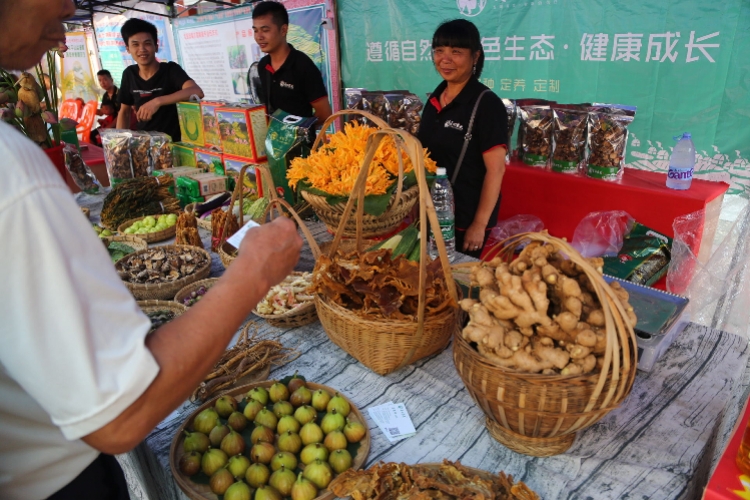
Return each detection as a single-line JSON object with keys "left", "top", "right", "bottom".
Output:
{"left": 169, "top": 380, "right": 371, "bottom": 500}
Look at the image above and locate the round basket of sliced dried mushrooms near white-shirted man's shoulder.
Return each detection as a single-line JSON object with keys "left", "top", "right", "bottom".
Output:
{"left": 115, "top": 245, "right": 211, "bottom": 300}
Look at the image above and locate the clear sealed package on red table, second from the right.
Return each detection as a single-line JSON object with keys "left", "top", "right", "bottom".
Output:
{"left": 550, "top": 105, "right": 589, "bottom": 174}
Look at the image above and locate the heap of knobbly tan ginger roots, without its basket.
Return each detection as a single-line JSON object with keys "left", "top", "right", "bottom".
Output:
{"left": 461, "top": 242, "right": 636, "bottom": 375}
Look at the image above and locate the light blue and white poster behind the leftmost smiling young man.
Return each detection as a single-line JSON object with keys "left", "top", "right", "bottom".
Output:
{"left": 94, "top": 2, "right": 176, "bottom": 87}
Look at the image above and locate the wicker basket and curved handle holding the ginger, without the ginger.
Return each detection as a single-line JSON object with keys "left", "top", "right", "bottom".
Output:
{"left": 453, "top": 233, "right": 637, "bottom": 457}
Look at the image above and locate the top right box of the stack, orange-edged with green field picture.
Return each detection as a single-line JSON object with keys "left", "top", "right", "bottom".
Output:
{"left": 215, "top": 105, "right": 268, "bottom": 163}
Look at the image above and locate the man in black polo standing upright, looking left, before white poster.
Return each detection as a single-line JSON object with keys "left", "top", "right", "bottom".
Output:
{"left": 253, "top": 1, "right": 331, "bottom": 125}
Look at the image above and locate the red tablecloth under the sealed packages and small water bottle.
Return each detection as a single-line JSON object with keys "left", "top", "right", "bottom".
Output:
{"left": 499, "top": 160, "right": 729, "bottom": 240}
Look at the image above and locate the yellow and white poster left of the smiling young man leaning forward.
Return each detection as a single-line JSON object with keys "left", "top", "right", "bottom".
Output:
{"left": 59, "top": 31, "right": 99, "bottom": 102}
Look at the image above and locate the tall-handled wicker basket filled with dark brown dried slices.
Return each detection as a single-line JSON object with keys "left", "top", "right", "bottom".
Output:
{"left": 313, "top": 129, "right": 460, "bottom": 375}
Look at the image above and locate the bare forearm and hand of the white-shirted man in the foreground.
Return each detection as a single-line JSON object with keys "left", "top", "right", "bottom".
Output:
{"left": 82, "top": 217, "right": 302, "bottom": 455}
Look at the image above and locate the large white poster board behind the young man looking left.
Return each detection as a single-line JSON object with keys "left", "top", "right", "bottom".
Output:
{"left": 174, "top": 0, "right": 340, "bottom": 109}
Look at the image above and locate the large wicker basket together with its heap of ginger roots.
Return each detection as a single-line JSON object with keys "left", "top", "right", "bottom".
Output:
{"left": 453, "top": 233, "right": 637, "bottom": 456}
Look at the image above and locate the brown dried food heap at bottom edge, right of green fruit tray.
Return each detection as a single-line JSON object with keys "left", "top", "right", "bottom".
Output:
{"left": 329, "top": 460, "right": 539, "bottom": 500}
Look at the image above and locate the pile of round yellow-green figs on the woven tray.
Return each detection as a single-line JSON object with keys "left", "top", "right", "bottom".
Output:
{"left": 178, "top": 374, "right": 367, "bottom": 500}
